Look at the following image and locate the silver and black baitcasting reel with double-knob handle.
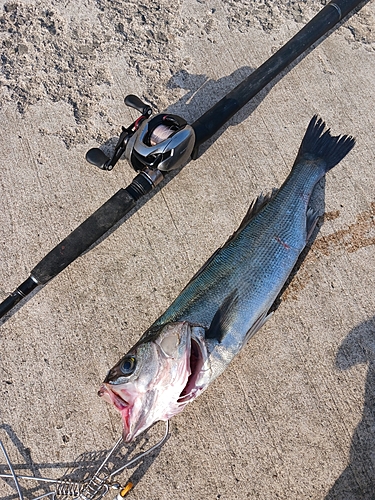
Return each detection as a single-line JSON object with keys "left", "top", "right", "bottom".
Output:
{"left": 86, "top": 95, "right": 195, "bottom": 175}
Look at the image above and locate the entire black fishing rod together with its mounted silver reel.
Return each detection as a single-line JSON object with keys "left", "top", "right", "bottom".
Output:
{"left": 0, "top": 0, "right": 366, "bottom": 318}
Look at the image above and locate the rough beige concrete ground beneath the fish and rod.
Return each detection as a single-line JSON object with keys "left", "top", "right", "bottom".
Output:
{"left": 0, "top": 0, "right": 375, "bottom": 500}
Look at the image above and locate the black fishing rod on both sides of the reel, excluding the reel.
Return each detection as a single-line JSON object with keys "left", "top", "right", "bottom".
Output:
{"left": 0, "top": 0, "right": 365, "bottom": 318}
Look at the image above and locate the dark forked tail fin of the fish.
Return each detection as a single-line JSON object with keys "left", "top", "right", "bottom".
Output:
{"left": 294, "top": 115, "right": 355, "bottom": 172}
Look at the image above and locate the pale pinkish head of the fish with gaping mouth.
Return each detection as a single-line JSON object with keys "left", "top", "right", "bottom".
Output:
{"left": 98, "top": 322, "right": 191, "bottom": 442}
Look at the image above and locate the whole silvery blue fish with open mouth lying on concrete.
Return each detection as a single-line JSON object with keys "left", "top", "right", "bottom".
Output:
{"left": 98, "top": 115, "right": 355, "bottom": 442}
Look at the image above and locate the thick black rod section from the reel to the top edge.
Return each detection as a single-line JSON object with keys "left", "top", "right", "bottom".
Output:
{"left": 192, "top": 0, "right": 363, "bottom": 154}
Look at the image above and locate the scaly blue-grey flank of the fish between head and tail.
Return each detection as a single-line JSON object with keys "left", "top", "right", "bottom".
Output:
{"left": 154, "top": 162, "right": 325, "bottom": 336}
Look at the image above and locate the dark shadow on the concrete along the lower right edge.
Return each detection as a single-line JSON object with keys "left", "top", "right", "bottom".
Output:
{"left": 325, "top": 316, "right": 375, "bottom": 500}
